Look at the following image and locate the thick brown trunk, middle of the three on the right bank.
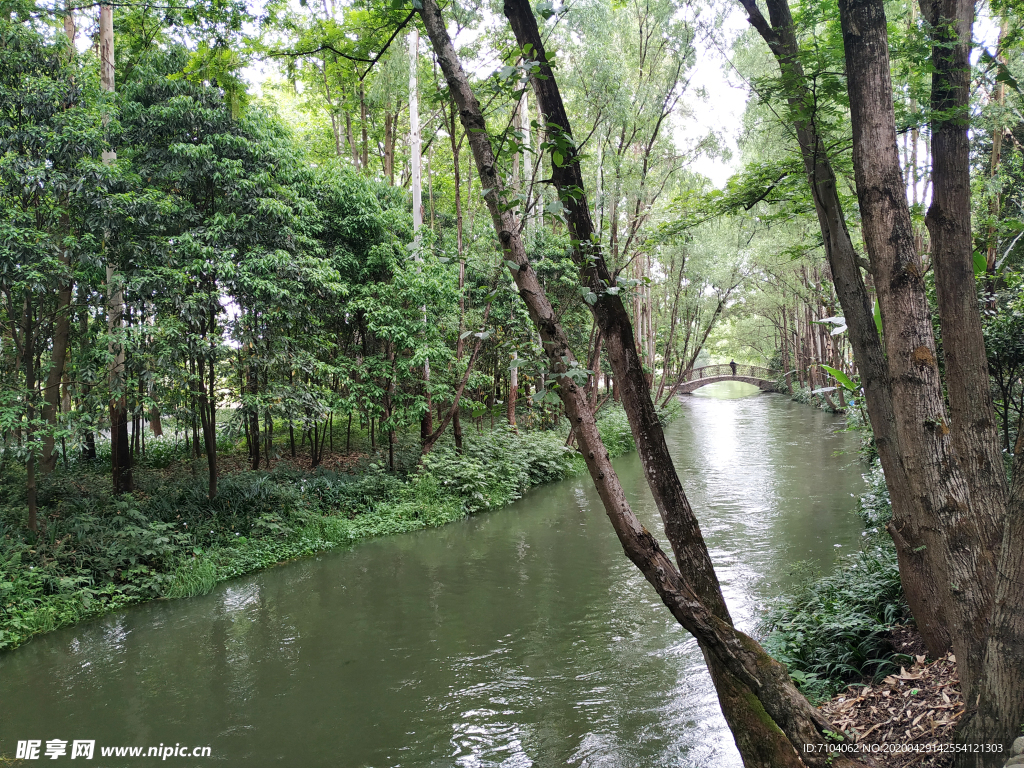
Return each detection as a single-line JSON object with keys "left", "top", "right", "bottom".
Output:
{"left": 840, "top": 0, "right": 1024, "bottom": 766}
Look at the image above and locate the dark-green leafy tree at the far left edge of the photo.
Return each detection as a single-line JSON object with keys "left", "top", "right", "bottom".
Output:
{"left": 0, "top": 24, "right": 112, "bottom": 530}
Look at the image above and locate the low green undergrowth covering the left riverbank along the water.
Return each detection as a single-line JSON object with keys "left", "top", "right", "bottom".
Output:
{"left": 0, "top": 408, "right": 633, "bottom": 649}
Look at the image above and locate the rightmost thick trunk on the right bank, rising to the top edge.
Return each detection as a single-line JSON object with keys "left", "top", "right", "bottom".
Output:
{"left": 921, "top": 0, "right": 1024, "bottom": 766}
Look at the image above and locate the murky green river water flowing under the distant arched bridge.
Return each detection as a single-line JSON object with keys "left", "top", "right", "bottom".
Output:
{"left": 0, "top": 383, "right": 863, "bottom": 768}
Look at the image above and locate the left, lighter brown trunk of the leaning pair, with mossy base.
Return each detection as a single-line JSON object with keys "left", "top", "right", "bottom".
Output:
{"left": 420, "top": 0, "right": 868, "bottom": 766}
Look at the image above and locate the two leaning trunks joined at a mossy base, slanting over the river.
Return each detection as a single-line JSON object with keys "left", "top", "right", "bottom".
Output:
{"left": 421, "top": 0, "right": 868, "bottom": 766}
